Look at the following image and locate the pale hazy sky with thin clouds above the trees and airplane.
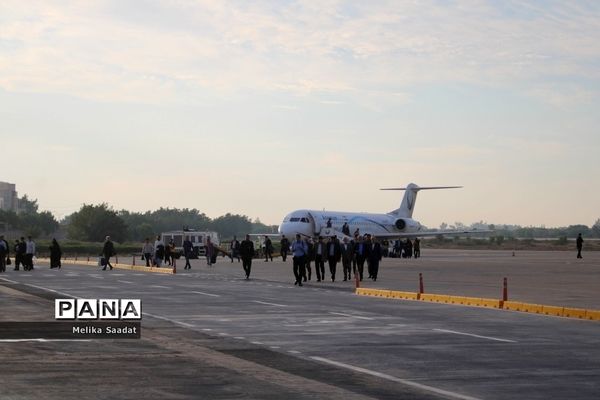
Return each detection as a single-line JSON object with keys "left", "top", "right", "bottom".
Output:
{"left": 0, "top": 0, "right": 600, "bottom": 227}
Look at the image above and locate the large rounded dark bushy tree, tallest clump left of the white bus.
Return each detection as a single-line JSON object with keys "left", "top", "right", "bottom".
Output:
{"left": 67, "top": 203, "right": 127, "bottom": 242}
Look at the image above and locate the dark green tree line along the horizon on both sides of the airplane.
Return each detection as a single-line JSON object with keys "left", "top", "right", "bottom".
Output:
{"left": 0, "top": 195, "right": 600, "bottom": 242}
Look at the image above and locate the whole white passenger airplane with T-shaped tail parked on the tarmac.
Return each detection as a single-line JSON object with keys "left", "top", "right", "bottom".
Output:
{"left": 274, "top": 183, "right": 491, "bottom": 240}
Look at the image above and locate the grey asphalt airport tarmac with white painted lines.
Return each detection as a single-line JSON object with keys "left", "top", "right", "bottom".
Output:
{"left": 0, "top": 251, "right": 600, "bottom": 399}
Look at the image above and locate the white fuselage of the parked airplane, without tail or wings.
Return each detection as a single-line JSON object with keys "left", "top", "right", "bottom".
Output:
{"left": 279, "top": 210, "right": 421, "bottom": 237}
